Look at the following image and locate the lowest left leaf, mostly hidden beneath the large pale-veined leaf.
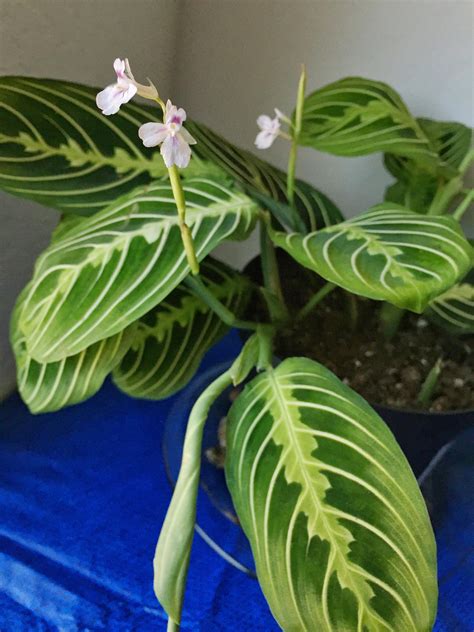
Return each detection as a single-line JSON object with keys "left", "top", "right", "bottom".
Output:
{"left": 11, "top": 288, "right": 134, "bottom": 413}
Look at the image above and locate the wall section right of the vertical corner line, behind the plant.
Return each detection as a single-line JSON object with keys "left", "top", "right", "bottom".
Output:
{"left": 176, "top": 0, "right": 474, "bottom": 263}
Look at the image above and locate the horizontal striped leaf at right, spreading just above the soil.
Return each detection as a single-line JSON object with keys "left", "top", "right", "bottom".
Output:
{"left": 272, "top": 203, "right": 472, "bottom": 312}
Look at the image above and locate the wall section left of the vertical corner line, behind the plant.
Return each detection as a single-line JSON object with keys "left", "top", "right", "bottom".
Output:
{"left": 0, "top": 0, "right": 178, "bottom": 399}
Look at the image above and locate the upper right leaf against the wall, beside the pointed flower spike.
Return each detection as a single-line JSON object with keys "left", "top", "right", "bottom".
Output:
{"left": 298, "top": 77, "right": 437, "bottom": 165}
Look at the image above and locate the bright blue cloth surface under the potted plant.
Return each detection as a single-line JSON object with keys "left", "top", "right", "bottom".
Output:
{"left": 0, "top": 332, "right": 474, "bottom": 632}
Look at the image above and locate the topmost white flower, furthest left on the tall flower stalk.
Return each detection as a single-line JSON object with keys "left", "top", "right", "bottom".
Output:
{"left": 95, "top": 57, "right": 158, "bottom": 116}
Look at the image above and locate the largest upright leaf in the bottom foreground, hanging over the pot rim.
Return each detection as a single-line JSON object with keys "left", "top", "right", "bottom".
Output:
{"left": 226, "top": 358, "right": 437, "bottom": 632}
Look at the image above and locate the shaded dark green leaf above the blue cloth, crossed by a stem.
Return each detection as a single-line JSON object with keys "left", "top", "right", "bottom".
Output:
{"left": 114, "top": 259, "right": 251, "bottom": 399}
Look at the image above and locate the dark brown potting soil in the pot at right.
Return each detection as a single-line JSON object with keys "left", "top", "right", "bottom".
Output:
{"left": 246, "top": 251, "right": 474, "bottom": 412}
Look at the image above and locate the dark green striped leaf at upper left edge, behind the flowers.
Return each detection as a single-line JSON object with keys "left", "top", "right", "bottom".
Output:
{"left": 0, "top": 77, "right": 166, "bottom": 215}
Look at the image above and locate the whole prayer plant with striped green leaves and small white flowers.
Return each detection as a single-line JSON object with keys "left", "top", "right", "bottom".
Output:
{"left": 0, "top": 59, "right": 473, "bottom": 632}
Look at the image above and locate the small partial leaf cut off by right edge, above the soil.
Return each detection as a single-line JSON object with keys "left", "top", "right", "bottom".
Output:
{"left": 425, "top": 282, "right": 474, "bottom": 335}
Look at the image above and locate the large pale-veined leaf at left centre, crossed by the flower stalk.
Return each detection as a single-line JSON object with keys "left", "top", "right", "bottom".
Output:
{"left": 19, "top": 178, "right": 258, "bottom": 362}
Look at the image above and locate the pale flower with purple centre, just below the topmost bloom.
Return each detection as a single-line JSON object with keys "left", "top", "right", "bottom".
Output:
{"left": 138, "top": 99, "right": 196, "bottom": 168}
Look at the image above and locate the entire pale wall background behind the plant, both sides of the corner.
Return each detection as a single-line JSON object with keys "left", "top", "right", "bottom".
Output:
{"left": 0, "top": 0, "right": 474, "bottom": 397}
